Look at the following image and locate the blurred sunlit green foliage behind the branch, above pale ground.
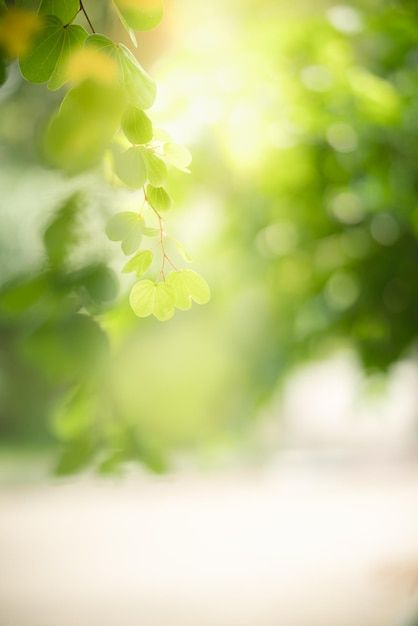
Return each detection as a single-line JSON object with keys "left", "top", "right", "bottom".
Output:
{"left": 0, "top": 0, "right": 418, "bottom": 472}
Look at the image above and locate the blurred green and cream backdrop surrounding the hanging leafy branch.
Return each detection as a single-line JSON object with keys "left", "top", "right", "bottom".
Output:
{"left": 0, "top": 0, "right": 418, "bottom": 626}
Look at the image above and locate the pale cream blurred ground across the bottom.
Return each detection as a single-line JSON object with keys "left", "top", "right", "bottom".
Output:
{"left": 0, "top": 462, "right": 418, "bottom": 626}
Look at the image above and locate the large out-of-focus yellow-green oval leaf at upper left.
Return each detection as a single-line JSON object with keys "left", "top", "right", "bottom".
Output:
{"left": 45, "top": 80, "right": 124, "bottom": 174}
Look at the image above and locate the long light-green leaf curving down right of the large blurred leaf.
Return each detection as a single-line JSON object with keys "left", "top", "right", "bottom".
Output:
{"left": 86, "top": 35, "right": 157, "bottom": 110}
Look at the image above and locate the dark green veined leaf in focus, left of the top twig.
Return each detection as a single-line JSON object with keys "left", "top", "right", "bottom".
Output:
{"left": 19, "top": 15, "right": 87, "bottom": 89}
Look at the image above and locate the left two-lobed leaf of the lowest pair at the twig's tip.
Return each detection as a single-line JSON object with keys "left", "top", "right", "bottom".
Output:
{"left": 129, "top": 280, "right": 174, "bottom": 322}
